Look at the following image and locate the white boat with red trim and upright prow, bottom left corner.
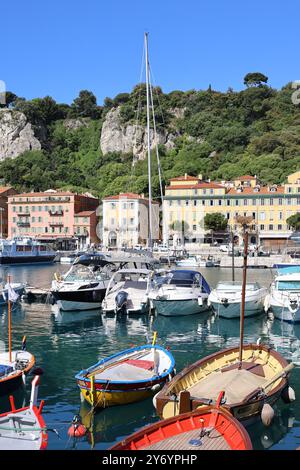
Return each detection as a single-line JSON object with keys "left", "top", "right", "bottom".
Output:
{"left": 0, "top": 375, "right": 48, "bottom": 450}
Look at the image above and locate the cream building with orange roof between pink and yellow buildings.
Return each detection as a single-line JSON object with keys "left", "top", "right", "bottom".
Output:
{"left": 102, "top": 193, "right": 159, "bottom": 248}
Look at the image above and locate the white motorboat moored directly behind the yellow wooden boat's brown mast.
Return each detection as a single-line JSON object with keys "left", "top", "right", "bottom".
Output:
{"left": 208, "top": 281, "right": 268, "bottom": 318}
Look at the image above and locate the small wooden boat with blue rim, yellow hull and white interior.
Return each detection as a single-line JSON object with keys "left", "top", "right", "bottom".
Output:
{"left": 75, "top": 338, "right": 175, "bottom": 408}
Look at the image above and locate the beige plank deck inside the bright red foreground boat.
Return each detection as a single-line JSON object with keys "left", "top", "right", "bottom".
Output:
{"left": 143, "top": 428, "right": 230, "bottom": 451}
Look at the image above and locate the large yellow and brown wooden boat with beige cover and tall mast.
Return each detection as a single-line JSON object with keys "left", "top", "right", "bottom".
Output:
{"left": 154, "top": 344, "right": 294, "bottom": 420}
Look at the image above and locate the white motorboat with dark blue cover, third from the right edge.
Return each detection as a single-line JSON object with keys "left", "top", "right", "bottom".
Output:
{"left": 149, "top": 270, "right": 210, "bottom": 316}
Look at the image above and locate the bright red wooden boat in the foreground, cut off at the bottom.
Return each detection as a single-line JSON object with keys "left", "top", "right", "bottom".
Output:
{"left": 110, "top": 392, "right": 252, "bottom": 451}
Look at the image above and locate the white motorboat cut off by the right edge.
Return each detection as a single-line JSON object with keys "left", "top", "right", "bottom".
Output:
{"left": 265, "top": 266, "right": 300, "bottom": 323}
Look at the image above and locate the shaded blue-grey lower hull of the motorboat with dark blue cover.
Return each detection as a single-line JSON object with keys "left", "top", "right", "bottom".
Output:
{"left": 152, "top": 299, "right": 209, "bottom": 317}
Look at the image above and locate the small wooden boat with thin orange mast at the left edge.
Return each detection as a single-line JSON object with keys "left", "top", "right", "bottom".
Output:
{"left": 0, "top": 276, "right": 35, "bottom": 396}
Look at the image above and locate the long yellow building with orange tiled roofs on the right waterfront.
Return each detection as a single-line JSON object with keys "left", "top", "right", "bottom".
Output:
{"left": 163, "top": 171, "right": 300, "bottom": 248}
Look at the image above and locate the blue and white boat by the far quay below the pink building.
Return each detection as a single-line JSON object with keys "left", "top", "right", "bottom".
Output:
{"left": 0, "top": 237, "right": 56, "bottom": 264}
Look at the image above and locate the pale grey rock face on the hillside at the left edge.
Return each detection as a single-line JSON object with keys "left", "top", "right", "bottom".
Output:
{"left": 0, "top": 109, "right": 41, "bottom": 160}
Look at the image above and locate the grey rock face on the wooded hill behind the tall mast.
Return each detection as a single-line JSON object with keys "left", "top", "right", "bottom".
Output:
{"left": 100, "top": 108, "right": 176, "bottom": 159}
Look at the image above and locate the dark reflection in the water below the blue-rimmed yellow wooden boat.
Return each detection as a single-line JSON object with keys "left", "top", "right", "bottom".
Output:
{"left": 79, "top": 399, "right": 158, "bottom": 444}
